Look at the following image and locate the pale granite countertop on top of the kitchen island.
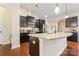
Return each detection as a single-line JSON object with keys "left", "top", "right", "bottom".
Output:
{"left": 28, "top": 32, "right": 72, "bottom": 39}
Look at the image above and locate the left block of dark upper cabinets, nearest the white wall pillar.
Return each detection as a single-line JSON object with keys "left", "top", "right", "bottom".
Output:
{"left": 20, "top": 16, "right": 34, "bottom": 27}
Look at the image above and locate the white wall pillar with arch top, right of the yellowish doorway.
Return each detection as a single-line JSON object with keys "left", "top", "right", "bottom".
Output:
{"left": 0, "top": 3, "right": 20, "bottom": 49}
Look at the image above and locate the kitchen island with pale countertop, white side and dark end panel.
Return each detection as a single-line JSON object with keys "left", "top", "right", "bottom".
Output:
{"left": 28, "top": 32, "right": 72, "bottom": 56}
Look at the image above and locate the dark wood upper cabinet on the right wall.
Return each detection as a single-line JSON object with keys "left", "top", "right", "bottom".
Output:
{"left": 65, "top": 16, "right": 78, "bottom": 27}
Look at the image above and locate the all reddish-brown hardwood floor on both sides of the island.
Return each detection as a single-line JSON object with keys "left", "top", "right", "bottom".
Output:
{"left": 0, "top": 41, "right": 79, "bottom": 56}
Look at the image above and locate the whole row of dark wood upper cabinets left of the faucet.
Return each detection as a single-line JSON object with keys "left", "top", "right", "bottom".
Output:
{"left": 20, "top": 16, "right": 45, "bottom": 32}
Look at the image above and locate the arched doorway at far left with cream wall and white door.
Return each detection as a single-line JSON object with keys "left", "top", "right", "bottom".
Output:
{"left": 0, "top": 6, "right": 11, "bottom": 55}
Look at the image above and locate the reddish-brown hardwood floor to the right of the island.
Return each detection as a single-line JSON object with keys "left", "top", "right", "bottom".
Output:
{"left": 61, "top": 41, "right": 79, "bottom": 56}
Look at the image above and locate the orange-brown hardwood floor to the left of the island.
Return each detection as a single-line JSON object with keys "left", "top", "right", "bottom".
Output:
{"left": 0, "top": 42, "right": 29, "bottom": 56}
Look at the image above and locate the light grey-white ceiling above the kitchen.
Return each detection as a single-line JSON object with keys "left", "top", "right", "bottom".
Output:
{"left": 21, "top": 3, "right": 79, "bottom": 19}
